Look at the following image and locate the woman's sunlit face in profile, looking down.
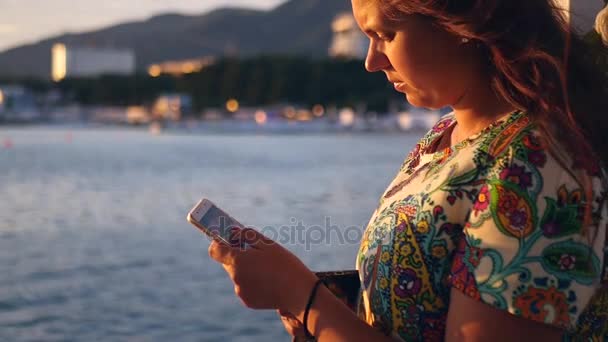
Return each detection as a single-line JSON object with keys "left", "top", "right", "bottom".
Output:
{"left": 352, "top": 0, "right": 475, "bottom": 108}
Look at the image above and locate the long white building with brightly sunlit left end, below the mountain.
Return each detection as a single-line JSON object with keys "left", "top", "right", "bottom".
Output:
{"left": 51, "top": 44, "right": 135, "bottom": 81}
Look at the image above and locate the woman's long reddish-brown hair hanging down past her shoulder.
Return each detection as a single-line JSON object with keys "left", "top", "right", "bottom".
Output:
{"left": 374, "top": 0, "right": 608, "bottom": 232}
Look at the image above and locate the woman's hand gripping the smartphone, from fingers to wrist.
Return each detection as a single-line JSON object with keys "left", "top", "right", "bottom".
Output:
{"left": 209, "top": 228, "right": 317, "bottom": 317}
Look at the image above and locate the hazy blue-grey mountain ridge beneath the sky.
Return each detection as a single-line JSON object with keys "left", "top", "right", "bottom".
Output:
{"left": 0, "top": 0, "right": 350, "bottom": 78}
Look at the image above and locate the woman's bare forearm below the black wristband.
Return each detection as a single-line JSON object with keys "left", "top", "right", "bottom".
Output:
{"left": 296, "top": 286, "right": 394, "bottom": 342}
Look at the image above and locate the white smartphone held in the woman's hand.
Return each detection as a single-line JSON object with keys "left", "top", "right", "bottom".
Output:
{"left": 187, "top": 198, "right": 244, "bottom": 246}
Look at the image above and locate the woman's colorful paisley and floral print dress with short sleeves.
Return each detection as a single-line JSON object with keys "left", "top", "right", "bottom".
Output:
{"left": 357, "top": 112, "right": 608, "bottom": 341}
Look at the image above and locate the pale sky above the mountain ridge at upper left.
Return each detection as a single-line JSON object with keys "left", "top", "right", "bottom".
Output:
{"left": 0, "top": 0, "right": 284, "bottom": 51}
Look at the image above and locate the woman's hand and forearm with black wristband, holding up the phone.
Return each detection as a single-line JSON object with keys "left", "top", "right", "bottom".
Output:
{"left": 209, "top": 229, "right": 391, "bottom": 342}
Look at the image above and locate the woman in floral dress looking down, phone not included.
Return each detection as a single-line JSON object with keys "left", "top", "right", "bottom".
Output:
{"left": 209, "top": 0, "right": 608, "bottom": 341}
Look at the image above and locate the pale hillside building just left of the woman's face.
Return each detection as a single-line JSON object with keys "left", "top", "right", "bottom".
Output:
{"left": 329, "top": 13, "right": 367, "bottom": 59}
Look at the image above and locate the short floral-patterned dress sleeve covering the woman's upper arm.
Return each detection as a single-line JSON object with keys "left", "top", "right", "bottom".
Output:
{"left": 450, "top": 144, "right": 606, "bottom": 331}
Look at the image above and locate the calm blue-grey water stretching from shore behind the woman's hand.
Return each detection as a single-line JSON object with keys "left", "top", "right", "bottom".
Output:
{"left": 0, "top": 127, "right": 417, "bottom": 341}
